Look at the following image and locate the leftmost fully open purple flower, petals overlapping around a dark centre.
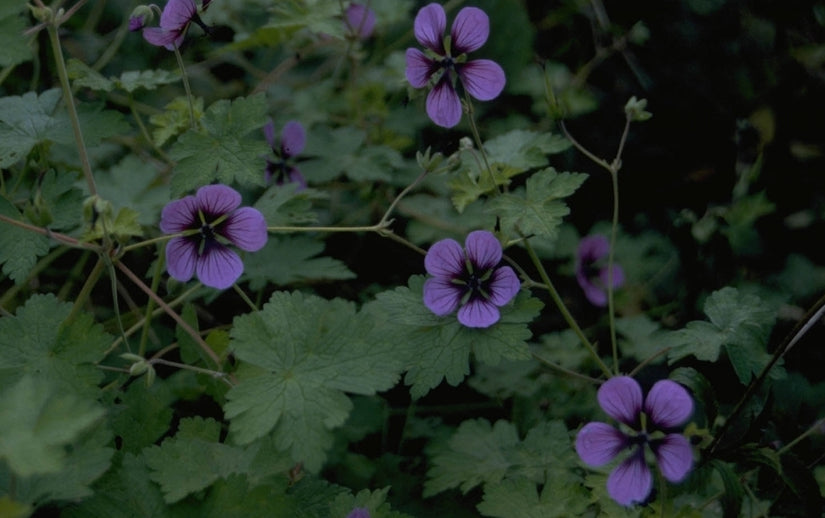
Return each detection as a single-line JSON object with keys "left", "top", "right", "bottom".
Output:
{"left": 160, "top": 185, "right": 267, "bottom": 289}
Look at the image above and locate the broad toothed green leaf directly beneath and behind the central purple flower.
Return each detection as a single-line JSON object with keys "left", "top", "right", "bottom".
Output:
{"left": 365, "top": 276, "right": 542, "bottom": 398}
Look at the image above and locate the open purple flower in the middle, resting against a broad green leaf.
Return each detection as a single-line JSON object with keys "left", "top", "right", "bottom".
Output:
{"left": 424, "top": 230, "right": 521, "bottom": 327}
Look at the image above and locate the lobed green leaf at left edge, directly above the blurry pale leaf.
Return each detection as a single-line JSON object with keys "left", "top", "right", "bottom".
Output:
{"left": 0, "top": 294, "right": 112, "bottom": 395}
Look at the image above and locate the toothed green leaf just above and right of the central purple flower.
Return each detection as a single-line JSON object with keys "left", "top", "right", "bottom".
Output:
{"left": 486, "top": 168, "right": 587, "bottom": 238}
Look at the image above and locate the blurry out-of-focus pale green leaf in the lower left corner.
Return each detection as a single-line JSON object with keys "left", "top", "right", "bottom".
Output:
{"left": 0, "top": 375, "right": 103, "bottom": 477}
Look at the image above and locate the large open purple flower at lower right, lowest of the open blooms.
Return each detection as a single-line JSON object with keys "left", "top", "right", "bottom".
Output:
{"left": 576, "top": 376, "right": 693, "bottom": 506}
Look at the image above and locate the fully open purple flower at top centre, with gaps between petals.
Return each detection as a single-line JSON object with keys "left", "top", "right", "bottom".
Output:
{"left": 406, "top": 4, "right": 506, "bottom": 128}
